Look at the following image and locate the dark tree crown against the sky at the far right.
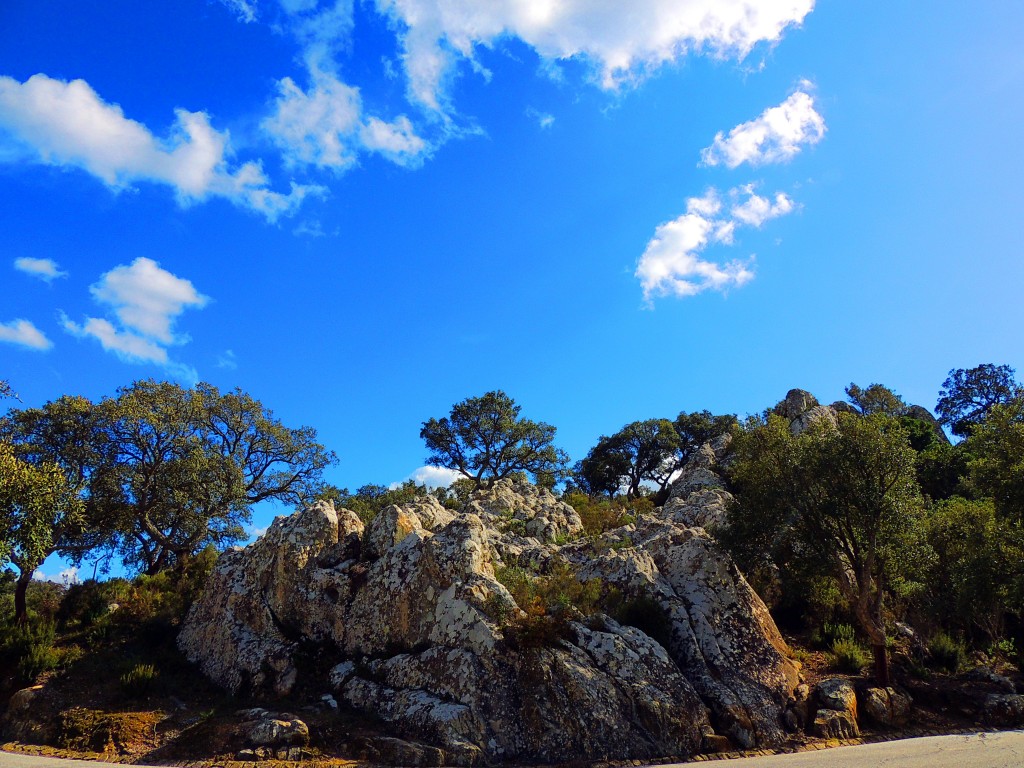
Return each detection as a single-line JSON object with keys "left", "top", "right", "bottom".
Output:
{"left": 935, "top": 362, "right": 1021, "bottom": 437}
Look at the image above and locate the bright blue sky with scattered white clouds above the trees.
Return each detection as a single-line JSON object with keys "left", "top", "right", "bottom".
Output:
{"left": 0, "top": 0, "right": 1024, "bottom": 573}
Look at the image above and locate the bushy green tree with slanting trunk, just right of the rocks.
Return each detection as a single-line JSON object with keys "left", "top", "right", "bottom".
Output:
{"left": 724, "top": 413, "right": 931, "bottom": 684}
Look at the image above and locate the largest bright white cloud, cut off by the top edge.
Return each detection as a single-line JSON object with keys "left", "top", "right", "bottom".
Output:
{"left": 376, "top": 0, "right": 814, "bottom": 112}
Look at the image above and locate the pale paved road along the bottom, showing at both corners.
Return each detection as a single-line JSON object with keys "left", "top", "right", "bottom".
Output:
{"left": 6, "top": 731, "right": 1024, "bottom": 768}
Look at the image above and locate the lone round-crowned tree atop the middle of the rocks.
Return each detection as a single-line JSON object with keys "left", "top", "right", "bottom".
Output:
{"left": 420, "top": 390, "right": 568, "bottom": 487}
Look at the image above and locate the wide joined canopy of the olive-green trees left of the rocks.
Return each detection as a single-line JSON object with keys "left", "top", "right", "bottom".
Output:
{"left": 0, "top": 381, "right": 335, "bottom": 573}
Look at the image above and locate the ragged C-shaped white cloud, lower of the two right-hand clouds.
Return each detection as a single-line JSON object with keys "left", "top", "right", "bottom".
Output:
{"left": 636, "top": 184, "right": 794, "bottom": 305}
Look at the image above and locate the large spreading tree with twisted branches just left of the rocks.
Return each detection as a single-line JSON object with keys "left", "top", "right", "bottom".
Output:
{"left": 99, "top": 381, "right": 335, "bottom": 574}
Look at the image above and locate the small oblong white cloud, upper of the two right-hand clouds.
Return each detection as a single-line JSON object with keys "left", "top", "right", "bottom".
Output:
{"left": 700, "top": 89, "right": 825, "bottom": 168}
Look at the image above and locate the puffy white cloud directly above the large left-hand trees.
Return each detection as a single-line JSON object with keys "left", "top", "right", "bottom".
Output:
{"left": 62, "top": 257, "right": 210, "bottom": 382}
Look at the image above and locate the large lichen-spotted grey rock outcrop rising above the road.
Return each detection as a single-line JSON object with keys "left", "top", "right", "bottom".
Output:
{"left": 178, "top": 442, "right": 799, "bottom": 765}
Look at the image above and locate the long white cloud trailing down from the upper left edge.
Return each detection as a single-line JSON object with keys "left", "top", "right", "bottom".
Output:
{"left": 0, "top": 74, "right": 324, "bottom": 221}
